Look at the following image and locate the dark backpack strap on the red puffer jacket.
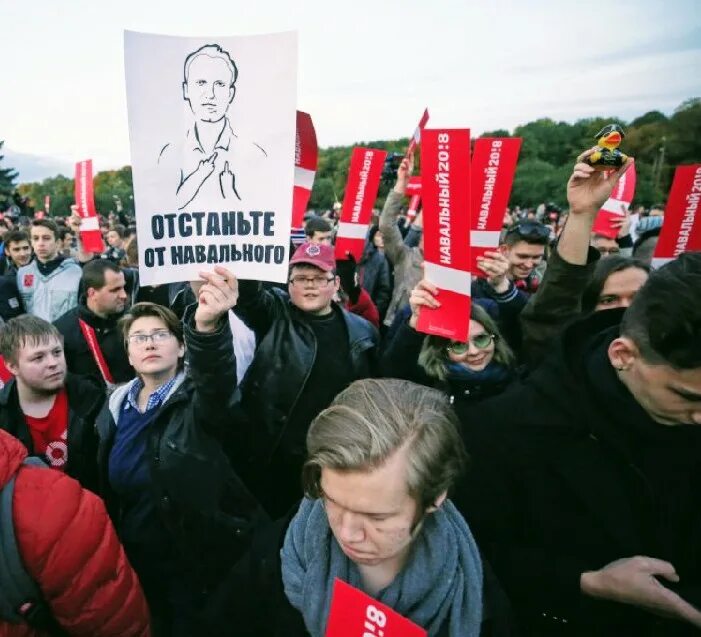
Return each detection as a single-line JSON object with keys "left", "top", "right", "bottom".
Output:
{"left": 0, "top": 456, "right": 65, "bottom": 635}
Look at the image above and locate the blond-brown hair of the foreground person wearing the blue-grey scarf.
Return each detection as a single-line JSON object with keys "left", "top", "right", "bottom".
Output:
{"left": 302, "top": 378, "right": 467, "bottom": 510}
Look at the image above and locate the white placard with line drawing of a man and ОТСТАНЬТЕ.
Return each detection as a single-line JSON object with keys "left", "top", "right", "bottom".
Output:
{"left": 124, "top": 31, "right": 297, "bottom": 285}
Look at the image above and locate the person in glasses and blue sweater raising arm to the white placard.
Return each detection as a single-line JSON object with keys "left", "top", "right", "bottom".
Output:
{"left": 97, "top": 267, "right": 263, "bottom": 637}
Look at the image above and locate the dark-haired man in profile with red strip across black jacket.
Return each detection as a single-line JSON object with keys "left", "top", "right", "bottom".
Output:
{"left": 54, "top": 259, "right": 134, "bottom": 387}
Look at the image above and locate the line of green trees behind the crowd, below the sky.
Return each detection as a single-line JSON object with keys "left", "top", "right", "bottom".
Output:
{"left": 0, "top": 98, "right": 701, "bottom": 215}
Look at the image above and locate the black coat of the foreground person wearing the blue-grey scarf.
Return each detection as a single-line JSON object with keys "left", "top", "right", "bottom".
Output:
{"left": 203, "top": 507, "right": 516, "bottom": 637}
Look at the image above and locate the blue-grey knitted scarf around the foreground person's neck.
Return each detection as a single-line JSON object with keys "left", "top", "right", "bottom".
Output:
{"left": 280, "top": 499, "right": 482, "bottom": 637}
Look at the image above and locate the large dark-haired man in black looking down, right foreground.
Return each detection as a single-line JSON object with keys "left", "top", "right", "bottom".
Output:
{"left": 455, "top": 149, "right": 701, "bottom": 636}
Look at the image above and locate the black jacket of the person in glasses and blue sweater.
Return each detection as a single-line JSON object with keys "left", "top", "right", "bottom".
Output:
{"left": 97, "top": 307, "right": 265, "bottom": 587}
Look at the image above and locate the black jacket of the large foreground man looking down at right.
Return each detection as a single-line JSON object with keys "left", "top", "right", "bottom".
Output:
{"left": 454, "top": 310, "right": 701, "bottom": 637}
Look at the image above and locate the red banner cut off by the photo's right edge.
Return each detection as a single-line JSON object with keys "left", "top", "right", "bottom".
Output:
{"left": 652, "top": 164, "right": 701, "bottom": 268}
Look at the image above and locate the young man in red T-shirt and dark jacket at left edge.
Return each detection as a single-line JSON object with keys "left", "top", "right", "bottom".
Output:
{"left": 0, "top": 314, "right": 104, "bottom": 490}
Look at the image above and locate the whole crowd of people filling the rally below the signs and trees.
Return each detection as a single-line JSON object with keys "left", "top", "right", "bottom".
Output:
{"left": 0, "top": 145, "right": 701, "bottom": 637}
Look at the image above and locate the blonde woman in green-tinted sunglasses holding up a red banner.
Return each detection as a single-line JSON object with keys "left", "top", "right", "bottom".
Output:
{"left": 381, "top": 280, "right": 515, "bottom": 402}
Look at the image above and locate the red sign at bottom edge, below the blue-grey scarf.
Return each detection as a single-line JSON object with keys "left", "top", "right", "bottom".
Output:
{"left": 326, "top": 579, "right": 428, "bottom": 637}
